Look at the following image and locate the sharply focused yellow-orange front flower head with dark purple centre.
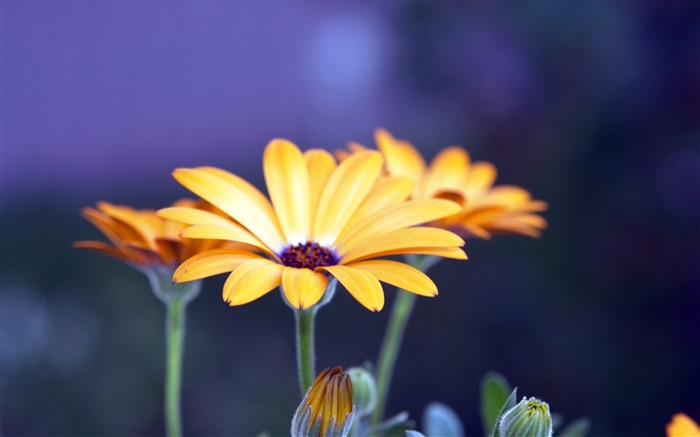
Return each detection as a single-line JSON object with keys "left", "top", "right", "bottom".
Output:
{"left": 159, "top": 140, "right": 466, "bottom": 311}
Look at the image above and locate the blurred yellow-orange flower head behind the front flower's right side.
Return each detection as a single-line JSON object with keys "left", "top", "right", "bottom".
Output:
{"left": 348, "top": 129, "right": 547, "bottom": 238}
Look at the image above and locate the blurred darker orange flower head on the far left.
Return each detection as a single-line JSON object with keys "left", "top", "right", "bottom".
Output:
{"left": 73, "top": 199, "right": 222, "bottom": 269}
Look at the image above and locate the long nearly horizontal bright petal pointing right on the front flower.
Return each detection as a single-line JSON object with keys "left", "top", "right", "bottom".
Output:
{"left": 340, "top": 227, "right": 464, "bottom": 264}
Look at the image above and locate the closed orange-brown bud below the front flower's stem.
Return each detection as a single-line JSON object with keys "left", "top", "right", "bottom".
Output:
{"left": 291, "top": 367, "right": 355, "bottom": 437}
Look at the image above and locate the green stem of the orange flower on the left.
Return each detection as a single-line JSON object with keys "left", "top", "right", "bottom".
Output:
{"left": 165, "top": 298, "right": 187, "bottom": 437}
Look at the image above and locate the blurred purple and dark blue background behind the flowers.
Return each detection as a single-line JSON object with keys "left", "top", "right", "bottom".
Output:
{"left": 0, "top": 0, "right": 700, "bottom": 436}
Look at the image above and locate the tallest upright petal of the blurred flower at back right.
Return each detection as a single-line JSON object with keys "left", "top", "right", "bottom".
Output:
{"left": 374, "top": 129, "right": 425, "bottom": 192}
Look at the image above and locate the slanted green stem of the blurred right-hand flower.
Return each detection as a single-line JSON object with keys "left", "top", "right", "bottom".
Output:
{"left": 370, "top": 256, "right": 439, "bottom": 426}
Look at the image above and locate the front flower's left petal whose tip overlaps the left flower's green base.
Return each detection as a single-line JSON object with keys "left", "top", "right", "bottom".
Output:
{"left": 173, "top": 249, "right": 260, "bottom": 282}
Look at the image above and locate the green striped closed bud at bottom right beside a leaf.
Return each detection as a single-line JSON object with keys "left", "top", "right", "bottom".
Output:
{"left": 498, "top": 397, "right": 552, "bottom": 437}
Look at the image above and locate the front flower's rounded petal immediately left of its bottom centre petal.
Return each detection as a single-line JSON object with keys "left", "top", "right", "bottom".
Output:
{"left": 223, "top": 258, "right": 284, "bottom": 306}
